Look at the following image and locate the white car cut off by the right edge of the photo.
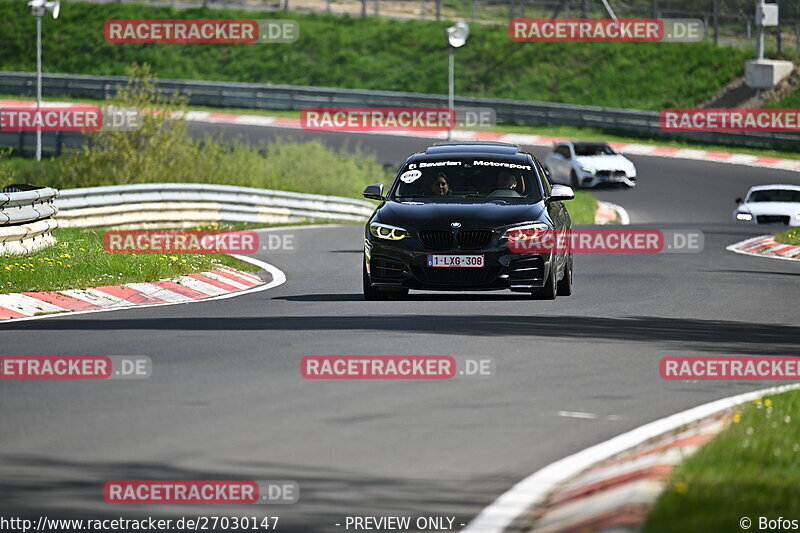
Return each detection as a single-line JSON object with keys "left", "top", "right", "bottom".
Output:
{"left": 733, "top": 185, "right": 800, "bottom": 226}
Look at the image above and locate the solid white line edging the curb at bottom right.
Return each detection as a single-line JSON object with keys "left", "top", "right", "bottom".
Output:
{"left": 461, "top": 383, "right": 800, "bottom": 533}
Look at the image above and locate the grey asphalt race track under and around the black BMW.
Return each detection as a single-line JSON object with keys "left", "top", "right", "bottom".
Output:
{"left": 0, "top": 126, "right": 800, "bottom": 532}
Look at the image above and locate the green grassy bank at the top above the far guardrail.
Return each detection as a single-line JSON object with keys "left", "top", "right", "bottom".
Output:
{"left": 0, "top": 0, "right": 752, "bottom": 110}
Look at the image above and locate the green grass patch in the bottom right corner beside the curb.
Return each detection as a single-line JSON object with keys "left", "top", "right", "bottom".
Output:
{"left": 644, "top": 391, "right": 800, "bottom": 533}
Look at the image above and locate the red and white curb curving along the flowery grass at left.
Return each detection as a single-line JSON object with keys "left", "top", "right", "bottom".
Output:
{"left": 0, "top": 255, "right": 286, "bottom": 323}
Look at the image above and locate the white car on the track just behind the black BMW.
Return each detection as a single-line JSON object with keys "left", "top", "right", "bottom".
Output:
{"left": 544, "top": 141, "right": 636, "bottom": 189}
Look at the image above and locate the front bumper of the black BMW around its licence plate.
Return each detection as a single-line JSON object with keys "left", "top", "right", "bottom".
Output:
{"left": 364, "top": 238, "right": 553, "bottom": 292}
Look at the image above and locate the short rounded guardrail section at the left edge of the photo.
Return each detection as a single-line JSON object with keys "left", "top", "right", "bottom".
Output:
{"left": 0, "top": 185, "right": 58, "bottom": 254}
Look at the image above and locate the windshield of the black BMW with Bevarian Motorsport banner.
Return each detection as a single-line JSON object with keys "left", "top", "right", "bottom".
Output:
{"left": 393, "top": 158, "right": 542, "bottom": 202}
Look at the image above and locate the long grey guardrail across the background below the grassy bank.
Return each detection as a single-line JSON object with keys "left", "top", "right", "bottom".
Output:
{"left": 0, "top": 72, "right": 800, "bottom": 152}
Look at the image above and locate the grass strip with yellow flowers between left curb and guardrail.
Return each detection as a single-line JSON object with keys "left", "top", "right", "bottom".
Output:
{"left": 0, "top": 223, "right": 258, "bottom": 293}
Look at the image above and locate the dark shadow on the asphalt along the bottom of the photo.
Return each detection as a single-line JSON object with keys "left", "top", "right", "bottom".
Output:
{"left": 0, "top": 454, "right": 500, "bottom": 533}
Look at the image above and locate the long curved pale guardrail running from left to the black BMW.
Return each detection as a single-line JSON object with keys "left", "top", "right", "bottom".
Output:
{"left": 56, "top": 183, "right": 375, "bottom": 228}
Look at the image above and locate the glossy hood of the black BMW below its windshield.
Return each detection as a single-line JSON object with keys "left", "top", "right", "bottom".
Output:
{"left": 377, "top": 200, "right": 545, "bottom": 229}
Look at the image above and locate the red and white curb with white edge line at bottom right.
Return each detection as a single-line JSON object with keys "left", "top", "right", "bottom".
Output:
{"left": 461, "top": 383, "right": 800, "bottom": 533}
